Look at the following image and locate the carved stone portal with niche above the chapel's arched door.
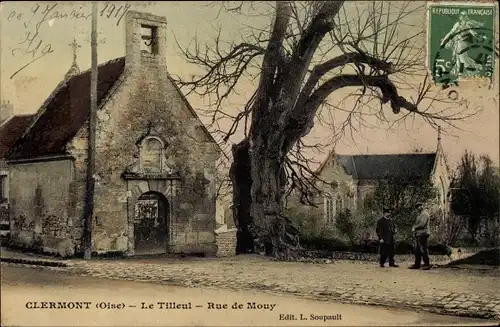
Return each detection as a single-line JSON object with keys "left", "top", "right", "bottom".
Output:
{"left": 122, "top": 124, "right": 180, "bottom": 254}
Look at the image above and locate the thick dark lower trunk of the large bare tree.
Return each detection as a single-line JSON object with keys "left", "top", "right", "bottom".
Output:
{"left": 231, "top": 135, "right": 298, "bottom": 258}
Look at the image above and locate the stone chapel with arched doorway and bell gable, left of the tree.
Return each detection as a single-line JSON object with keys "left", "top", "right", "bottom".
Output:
{"left": 6, "top": 11, "right": 220, "bottom": 255}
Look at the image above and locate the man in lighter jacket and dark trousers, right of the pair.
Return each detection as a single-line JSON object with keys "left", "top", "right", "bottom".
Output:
{"left": 410, "top": 203, "right": 430, "bottom": 270}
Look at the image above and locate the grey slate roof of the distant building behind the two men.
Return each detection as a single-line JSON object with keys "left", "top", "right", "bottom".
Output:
{"left": 335, "top": 153, "right": 436, "bottom": 180}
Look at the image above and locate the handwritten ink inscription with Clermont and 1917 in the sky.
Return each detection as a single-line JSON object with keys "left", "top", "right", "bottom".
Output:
{"left": 7, "top": 3, "right": 135, "bottom": 79}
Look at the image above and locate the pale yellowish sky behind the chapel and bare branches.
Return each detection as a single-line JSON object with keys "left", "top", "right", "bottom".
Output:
{"left": 0, "top": 1, "right": 499, "bottom": 172}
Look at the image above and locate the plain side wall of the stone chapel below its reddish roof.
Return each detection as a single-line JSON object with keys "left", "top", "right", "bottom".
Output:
{"left": 9, "top": 158, "right": 74, "bottom": 256}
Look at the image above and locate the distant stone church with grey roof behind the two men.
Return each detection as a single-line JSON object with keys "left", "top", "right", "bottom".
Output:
{"left": 291, "top": 132, "right": 450, "bottom": 232}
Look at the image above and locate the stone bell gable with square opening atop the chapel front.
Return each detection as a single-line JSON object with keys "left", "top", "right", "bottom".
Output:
{"left": 125, "top": 11, "right": 167, "bottom": 76}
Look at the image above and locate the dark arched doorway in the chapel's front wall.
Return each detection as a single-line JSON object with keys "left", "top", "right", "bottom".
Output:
{"left": 134, "top": 192, "right": 169, "bottom": 254}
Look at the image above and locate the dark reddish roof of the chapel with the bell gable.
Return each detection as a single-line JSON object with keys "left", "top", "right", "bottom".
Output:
{"left": 7, "top": 57, "right": 221, "bottom": 163}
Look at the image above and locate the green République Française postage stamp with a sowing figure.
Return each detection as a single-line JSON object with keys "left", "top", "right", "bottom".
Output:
{"left": 427, "top": 4, "right": 496, "bottom": 87}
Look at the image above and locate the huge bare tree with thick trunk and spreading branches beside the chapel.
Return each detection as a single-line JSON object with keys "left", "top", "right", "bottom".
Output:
{"left": 174, "top": 1, "right": 478, "bottom": 258}
